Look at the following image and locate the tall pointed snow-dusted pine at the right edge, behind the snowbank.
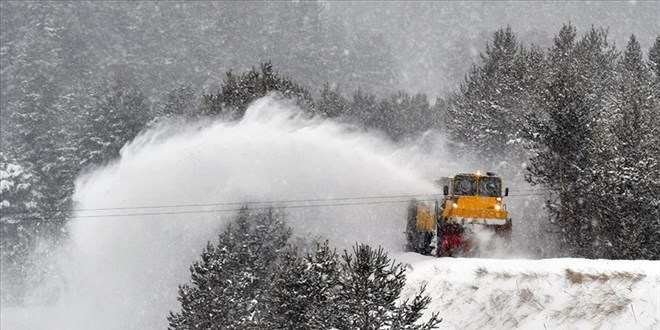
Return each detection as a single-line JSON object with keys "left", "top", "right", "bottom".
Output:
{"left": 595, "top": 35, "right": 660, "bottom": 259}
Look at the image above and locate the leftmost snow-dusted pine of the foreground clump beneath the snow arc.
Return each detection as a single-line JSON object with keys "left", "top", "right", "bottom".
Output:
{"left": 168, "top": 208, "right": 291, "bottom": 329}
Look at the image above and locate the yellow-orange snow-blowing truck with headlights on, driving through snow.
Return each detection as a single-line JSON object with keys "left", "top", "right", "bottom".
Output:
{"left": 406, "top": 172, "right": 512, "bottom": 257}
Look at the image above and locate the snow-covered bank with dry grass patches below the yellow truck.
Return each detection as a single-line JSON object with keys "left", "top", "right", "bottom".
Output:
{"left": 394, "top": 253, "right": 660, "bottom": 329}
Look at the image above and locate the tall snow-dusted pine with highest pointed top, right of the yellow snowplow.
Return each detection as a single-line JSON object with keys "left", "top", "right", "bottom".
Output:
{"left": 528, "top": 26, "right": 591, "bottom": 258}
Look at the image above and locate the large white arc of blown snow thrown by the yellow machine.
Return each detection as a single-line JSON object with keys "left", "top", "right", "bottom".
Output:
{"left": 48, "top": 96, "right": 451, "bottom": 329}
